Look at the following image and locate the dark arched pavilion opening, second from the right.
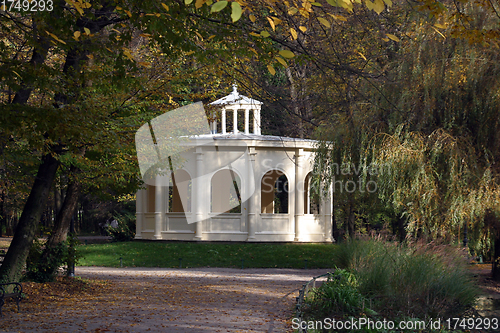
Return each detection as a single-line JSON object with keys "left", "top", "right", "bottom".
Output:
{"left": 261, "top": 170, "right": 288, "bottom": 214}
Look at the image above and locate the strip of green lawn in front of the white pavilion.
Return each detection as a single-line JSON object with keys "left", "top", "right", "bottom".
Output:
{"left": 77, "top": 241, "right": 336, "bottom": 268}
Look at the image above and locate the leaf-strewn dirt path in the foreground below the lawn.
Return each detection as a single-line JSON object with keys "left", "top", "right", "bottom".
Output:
{"left": 0, "top": 267, "right": 332, "bottom": 333}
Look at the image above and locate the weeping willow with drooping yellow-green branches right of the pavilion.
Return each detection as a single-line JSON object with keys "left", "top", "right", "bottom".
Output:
{"left": 316, "top": 1, "right": 500, "bottom": 251}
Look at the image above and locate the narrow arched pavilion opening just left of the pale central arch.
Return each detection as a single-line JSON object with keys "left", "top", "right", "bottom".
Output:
{"left": 168, "top": 170, "right": 192, "bottom": 213}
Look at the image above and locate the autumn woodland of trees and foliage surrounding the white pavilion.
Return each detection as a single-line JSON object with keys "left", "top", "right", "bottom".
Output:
{"left": 0, "top": 0, "right": 500, "bottom": 280}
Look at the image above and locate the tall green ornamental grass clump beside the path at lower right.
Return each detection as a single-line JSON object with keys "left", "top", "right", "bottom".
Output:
{"left": 335, "top": 240, "right": 478, "bottom": 318}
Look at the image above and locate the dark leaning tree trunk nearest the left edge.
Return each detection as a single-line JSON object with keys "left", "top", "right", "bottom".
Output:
{"left": 0, "top": 154, "right": 59, "bottom": 282}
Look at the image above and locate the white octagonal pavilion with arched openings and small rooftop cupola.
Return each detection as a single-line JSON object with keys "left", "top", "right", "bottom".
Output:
{"left": 135, "top": 87, "right": 332, "bottom": 242}
